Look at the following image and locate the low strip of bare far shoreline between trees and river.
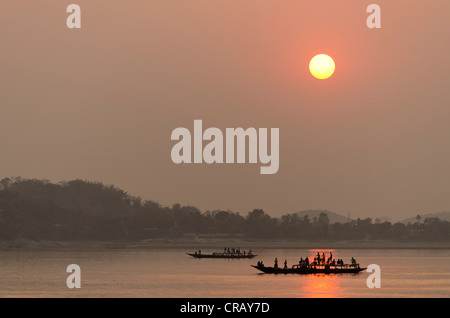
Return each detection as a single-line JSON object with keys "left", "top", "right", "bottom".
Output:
{"left": 0, "top": 238, "right": 450, "bottom": 251}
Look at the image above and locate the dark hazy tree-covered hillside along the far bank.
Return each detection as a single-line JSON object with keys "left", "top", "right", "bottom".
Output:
{"left": 0, "top": 178, "right": 450, "bottom": 241}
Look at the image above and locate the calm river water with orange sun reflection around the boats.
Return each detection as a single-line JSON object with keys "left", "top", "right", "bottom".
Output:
{"left": 0, "top": 249, "right": 450, "bottom": 298}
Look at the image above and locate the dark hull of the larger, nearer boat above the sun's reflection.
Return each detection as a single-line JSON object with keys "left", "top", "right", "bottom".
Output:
{"left": 251, "top": 264, "right": 366, "bottom": 274}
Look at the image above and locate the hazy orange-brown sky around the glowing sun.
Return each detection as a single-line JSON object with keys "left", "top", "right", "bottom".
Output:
{"left": 0, "top": 0, "right": 450, "bottom": 221}
